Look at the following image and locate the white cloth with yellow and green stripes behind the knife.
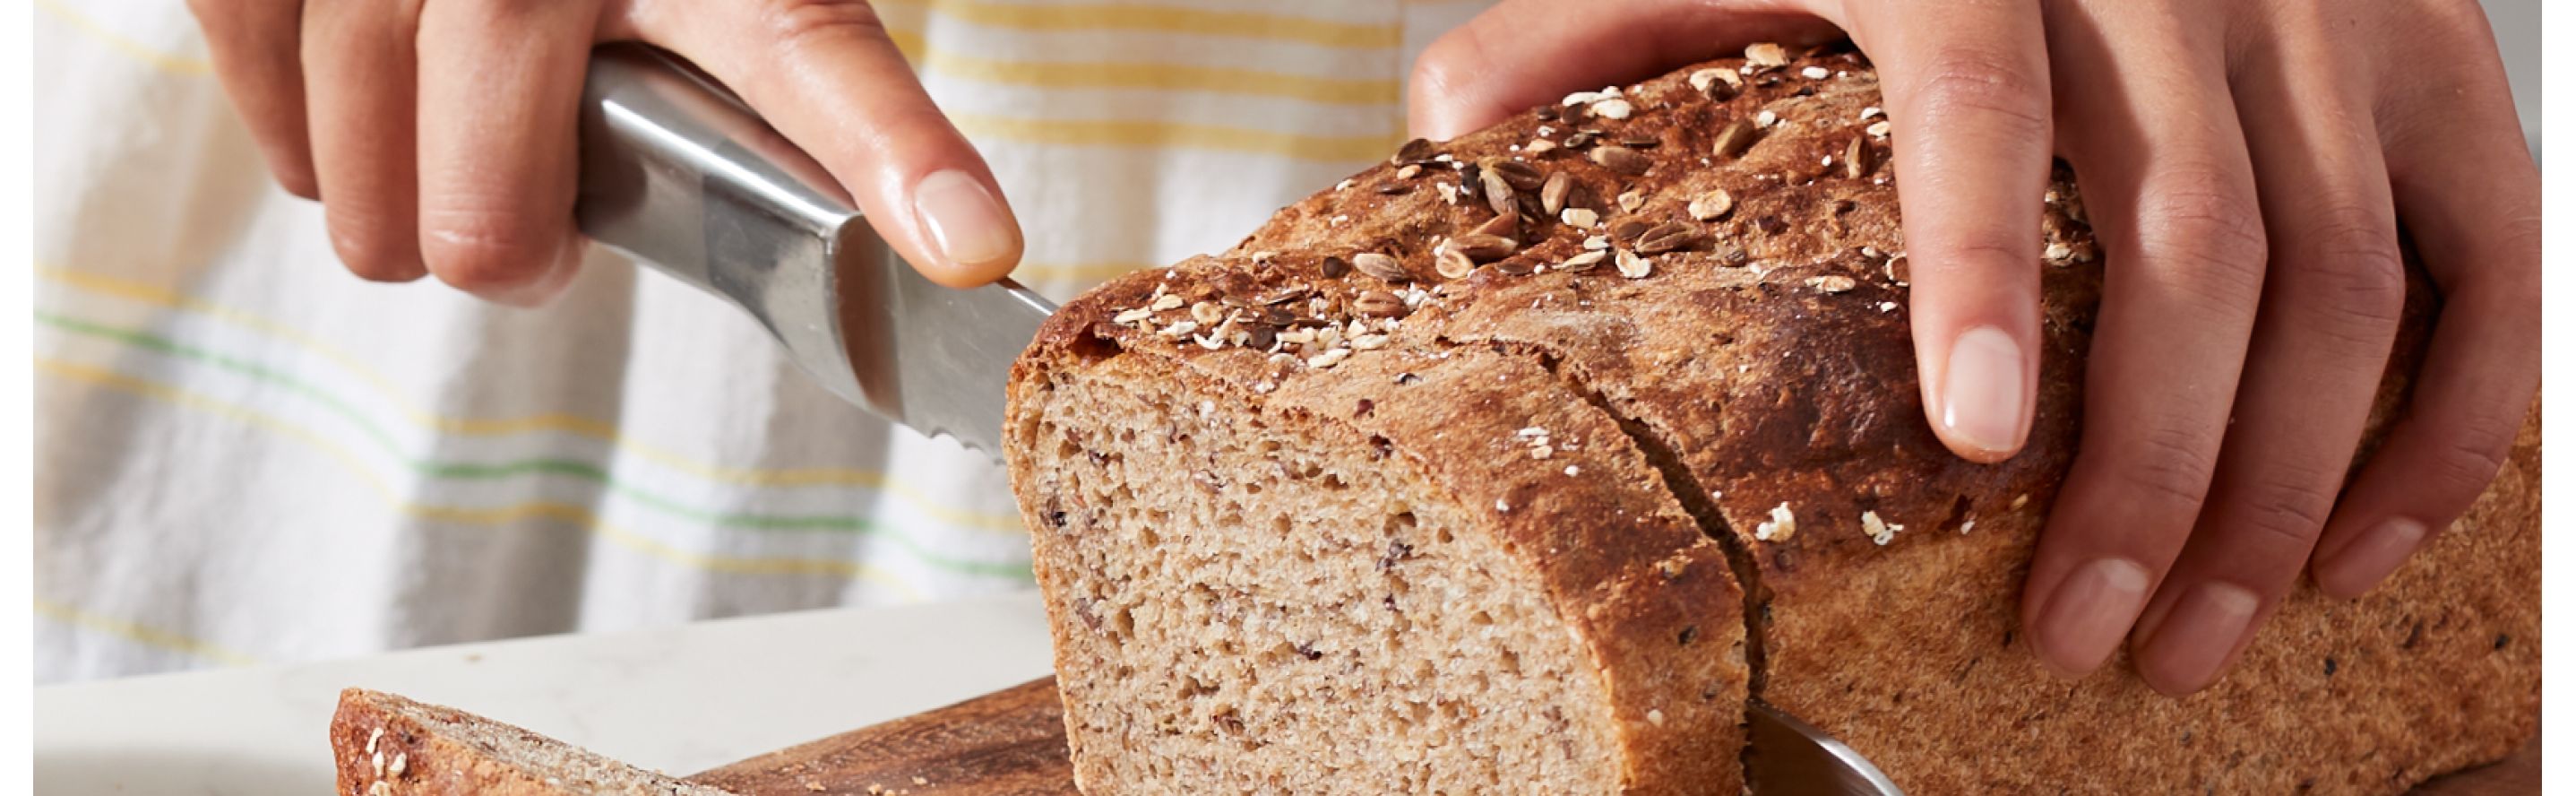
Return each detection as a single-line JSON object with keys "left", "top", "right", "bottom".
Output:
{"left": 33, "top": 0, "right": 1481, "bottom": 680}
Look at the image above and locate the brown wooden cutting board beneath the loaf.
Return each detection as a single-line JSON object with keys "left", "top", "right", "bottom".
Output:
{"left": 693, "top": 678, "right": 2540, "bottom": 796}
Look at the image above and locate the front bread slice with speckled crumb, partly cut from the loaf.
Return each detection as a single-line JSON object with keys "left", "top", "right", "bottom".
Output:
{"left": 1012, "top": 342, "right": 1744, "bottom": 793}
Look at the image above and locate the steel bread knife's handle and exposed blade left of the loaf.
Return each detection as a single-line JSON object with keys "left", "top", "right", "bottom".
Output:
{"left": 572, "top": 44, "right": 1056, "bottom": 459}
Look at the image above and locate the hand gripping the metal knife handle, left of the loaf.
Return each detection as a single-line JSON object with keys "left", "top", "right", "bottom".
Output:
{"left": 191, "top": 0, "right": 1021, "bottom": 304}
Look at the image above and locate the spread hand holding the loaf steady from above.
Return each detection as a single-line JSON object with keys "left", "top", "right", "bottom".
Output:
{"left": 1412, "top": 0, "right": 2540, "bottom": 696}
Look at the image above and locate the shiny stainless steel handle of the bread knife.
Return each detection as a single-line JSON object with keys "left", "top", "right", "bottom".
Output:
{"left": 572, "top": 44, "right": 881, "bottom": 402}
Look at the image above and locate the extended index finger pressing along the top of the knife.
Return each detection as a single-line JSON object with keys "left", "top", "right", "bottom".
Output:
{"left": 633, "top": 0, "right": 1022, "bottom": 286}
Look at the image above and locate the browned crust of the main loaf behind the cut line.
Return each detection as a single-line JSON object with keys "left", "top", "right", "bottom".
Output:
{"left": 999, "top": 41, "right": 2540, "bottom": 793}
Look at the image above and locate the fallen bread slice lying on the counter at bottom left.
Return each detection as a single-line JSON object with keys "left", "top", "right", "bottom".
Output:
{"left": 330, "top": 688, "right": 732, "bottom": 796}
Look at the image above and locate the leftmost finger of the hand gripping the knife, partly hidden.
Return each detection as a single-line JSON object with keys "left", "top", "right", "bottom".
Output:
{"left": 188, "top": 0, "right": 320, "bottom": 198}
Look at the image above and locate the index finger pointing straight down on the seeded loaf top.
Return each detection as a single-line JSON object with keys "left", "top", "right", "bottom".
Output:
{"left": 1852, "top": 0, "right": 2053, "bottom": 461}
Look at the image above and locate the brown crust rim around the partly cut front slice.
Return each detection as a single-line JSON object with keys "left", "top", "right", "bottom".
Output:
{"left": 1007, "top": 260, "right": 1746, "bottom": 793}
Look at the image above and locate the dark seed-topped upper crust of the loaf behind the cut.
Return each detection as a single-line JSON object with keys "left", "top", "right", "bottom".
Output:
{"left": 1048, "top": 47, "right": 2099, "bottom": 558}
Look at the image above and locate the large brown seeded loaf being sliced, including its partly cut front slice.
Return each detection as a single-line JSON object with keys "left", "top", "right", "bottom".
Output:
{"left": 1007, "top": 47, "right": 2540, "bottom": 793}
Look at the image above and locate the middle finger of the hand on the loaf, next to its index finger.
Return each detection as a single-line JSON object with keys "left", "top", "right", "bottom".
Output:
{"left": 2022, "top": 5, "right": 2267, "bottom": 678}
